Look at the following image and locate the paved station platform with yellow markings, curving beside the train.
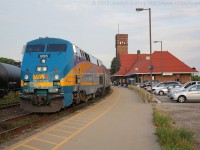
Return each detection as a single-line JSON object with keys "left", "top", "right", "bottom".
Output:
{"left": 5, "top": 87, "right": 161, "bottom": 150}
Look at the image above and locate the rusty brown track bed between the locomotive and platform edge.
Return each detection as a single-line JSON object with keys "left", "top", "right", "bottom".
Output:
{"left": 0, "top": 92, "right": 111, "bottom": 144}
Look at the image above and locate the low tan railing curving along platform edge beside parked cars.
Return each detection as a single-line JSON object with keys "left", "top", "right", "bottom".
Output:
{"left": 128, "top": 85, "right": 154, "bottom": 103}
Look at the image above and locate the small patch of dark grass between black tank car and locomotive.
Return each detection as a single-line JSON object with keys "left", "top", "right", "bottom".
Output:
{"left": 0, "top": 92, "right": 20, "bottom": 105}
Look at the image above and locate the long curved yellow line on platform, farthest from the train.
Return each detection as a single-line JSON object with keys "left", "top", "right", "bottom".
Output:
{"left": 52, "top": 95, "right": 120, "bottom": 150}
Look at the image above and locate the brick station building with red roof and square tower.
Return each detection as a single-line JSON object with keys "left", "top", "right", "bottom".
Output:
{"left": 112, "top": 34, "right": 198, "bottom": 83}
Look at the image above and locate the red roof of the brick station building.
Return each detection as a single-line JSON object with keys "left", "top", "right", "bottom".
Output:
{"left": 113, "top": 51, "right": 198, "bottom": 76}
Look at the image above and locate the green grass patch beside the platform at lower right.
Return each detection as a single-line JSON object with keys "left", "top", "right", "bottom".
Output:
{"left": 153, "top": 109, "right": 195, "bottom": 150}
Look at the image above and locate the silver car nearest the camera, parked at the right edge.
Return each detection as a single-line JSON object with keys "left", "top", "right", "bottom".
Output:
{"left": 170, "top": 84, "right": 200, "bottom": 103}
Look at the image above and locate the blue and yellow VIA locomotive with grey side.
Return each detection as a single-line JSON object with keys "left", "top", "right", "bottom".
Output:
{"left": 21, "top": 37, "right": 110, "bottom": 112}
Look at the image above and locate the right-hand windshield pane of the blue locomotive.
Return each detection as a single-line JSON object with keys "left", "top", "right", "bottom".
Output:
{"left": 47, "top": 44, "right": 67, "bottom": 52}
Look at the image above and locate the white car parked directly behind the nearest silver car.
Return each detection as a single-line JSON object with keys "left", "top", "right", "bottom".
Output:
{"left": 167, "top": 81, "right": 200, "bottom": 98}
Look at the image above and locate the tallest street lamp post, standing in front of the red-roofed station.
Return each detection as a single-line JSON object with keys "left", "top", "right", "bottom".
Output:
{"left": 136, "top": 8, "right": 153, "bottom": 94}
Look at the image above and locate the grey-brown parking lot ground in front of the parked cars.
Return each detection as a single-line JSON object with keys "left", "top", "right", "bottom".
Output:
{"left": 155, "top": 95, "right": 200, "bottom": 149}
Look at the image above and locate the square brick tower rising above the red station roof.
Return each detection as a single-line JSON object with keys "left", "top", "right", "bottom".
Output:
{"left": 115, "top": 34, "right": 128, "bottom": 58}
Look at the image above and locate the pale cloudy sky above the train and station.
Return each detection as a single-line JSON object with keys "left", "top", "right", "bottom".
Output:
{"left": 0, "top": 0, "right": 200, "bottom": 71}
